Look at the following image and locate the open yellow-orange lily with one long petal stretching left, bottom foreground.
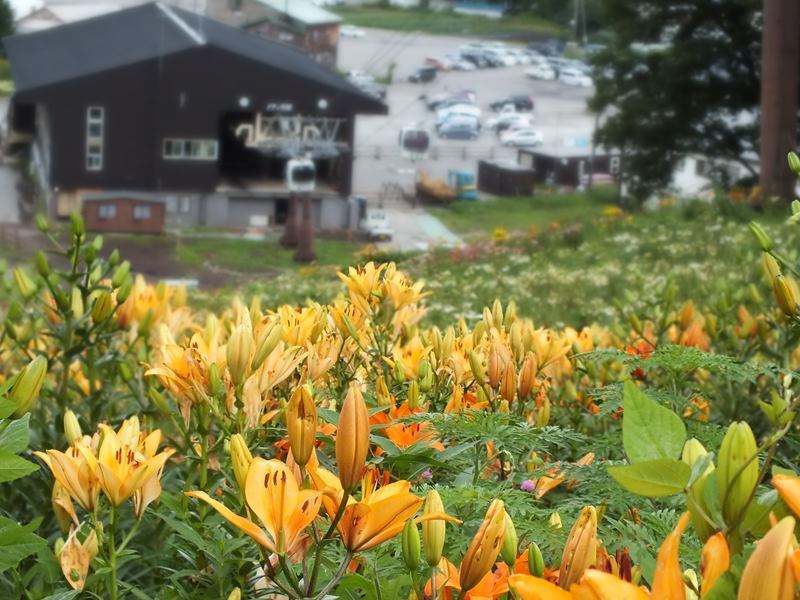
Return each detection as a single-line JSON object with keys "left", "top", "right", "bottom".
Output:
{"left": 186, "top": 458, "right": 322, "bottom": 557}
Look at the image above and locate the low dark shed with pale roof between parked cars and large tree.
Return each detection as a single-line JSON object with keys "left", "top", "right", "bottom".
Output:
{"left": 517, "top": 146, "right": 620, "bottom": 187}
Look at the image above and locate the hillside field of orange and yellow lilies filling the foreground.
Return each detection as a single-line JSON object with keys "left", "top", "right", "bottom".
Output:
{"left": 0, "top": 180, "right": 800, "bottom": 600}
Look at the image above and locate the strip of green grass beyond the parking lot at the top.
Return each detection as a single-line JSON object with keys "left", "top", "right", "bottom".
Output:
{"left": 336, "top": 6, "right": 564, "bottom": 36}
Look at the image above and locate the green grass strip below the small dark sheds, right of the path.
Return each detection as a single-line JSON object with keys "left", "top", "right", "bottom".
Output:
{"left": 431, "top": 187, "right": 616, "bottom": 234}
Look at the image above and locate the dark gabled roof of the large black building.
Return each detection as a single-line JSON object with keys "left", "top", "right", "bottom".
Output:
{"left": 3, "top": 2, "right": 386, "bottom": 113}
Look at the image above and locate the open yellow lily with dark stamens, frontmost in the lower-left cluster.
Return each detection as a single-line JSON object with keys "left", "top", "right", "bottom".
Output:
{"left": 94, "top": 421, "right": 174, "bottom": 508}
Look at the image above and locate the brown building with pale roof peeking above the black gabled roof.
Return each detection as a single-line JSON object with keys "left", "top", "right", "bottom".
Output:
{"left": 207, "top": 0, "right": 341, "bottom": 68}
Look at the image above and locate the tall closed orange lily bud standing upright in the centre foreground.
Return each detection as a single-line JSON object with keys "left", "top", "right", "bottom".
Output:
{"left": 336, "top": 386, "right": 369, "bottom": 490}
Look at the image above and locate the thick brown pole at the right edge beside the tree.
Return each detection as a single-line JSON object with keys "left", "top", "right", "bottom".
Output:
{"left": 760, "top": 0, "right": 800, "bottom": 202}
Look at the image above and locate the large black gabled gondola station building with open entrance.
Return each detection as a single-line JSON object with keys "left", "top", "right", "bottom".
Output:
{"left": 5, "top": 3, "right": 386, "bottom": 229}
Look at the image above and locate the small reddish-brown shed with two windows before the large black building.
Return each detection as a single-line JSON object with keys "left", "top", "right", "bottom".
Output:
{"left": 82, "top": 194, "right": 165, "bottom": 233}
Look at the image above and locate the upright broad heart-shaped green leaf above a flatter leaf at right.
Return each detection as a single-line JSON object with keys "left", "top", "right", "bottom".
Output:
{"left": 622, "top": 381, "right": 686, "bottom": 463}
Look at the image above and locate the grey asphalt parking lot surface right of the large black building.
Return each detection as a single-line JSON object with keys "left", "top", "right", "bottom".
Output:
{"left": 339, "top": 29, "right": 594, "bottom": 199}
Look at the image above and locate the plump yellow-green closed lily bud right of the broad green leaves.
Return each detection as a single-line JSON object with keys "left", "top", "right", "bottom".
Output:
{"left": 717, "top": 421, "right": 758, "bottom": 523}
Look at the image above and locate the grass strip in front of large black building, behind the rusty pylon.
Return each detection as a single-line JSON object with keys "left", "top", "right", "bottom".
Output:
{"left": 175, "top": 238, "right": 359, "bottom": 273}
